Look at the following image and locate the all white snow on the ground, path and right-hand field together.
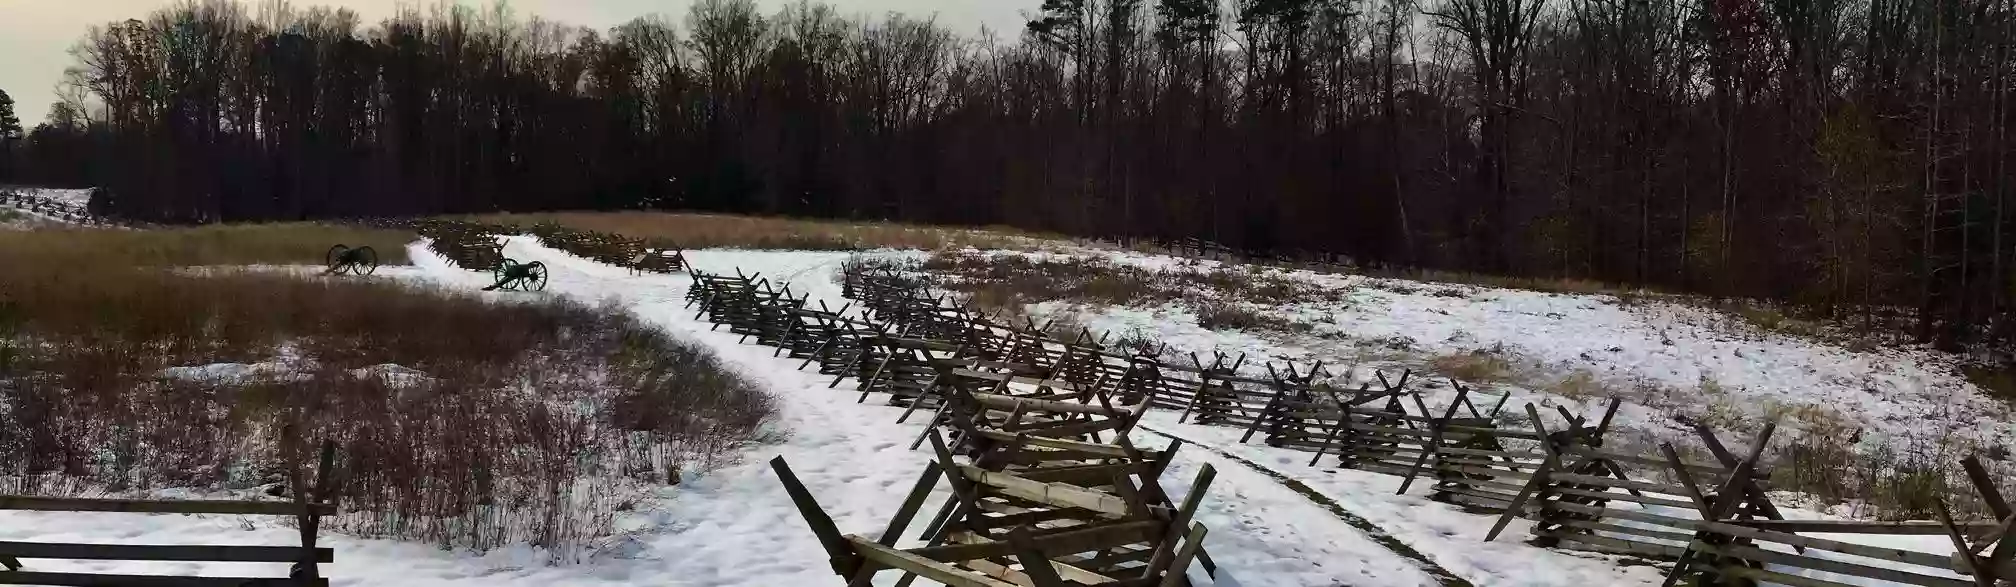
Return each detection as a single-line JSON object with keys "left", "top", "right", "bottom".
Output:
{"left": 0, "top": 238, "right": 2010, "bottom": 587}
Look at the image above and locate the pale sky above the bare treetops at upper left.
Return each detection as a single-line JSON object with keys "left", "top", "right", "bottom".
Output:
{"left": 0, "top": 0, "right": 1042, "bottom": 129}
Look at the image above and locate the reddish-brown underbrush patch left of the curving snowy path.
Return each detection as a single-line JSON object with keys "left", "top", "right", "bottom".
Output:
{"left": 0, "top": 228, "right": 774, "bottom": 561}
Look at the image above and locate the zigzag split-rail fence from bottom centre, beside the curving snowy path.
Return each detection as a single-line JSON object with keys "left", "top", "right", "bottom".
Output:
{"left": 687, "top": 264, "right": 1216, "bottom": 587}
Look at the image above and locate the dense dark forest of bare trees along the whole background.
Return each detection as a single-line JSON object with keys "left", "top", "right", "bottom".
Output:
{"left": 0, "top": 0, "right": 2016, "bottom": 343}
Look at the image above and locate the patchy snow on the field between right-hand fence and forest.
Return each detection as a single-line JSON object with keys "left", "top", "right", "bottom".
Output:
{"left": 978, "top": 248, "right": 2016, "bottom": 454}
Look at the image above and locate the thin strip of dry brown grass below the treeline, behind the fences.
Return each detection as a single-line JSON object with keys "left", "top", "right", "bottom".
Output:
{"left": 474, "top": 212, "right": 1060, "bottom": 250}
